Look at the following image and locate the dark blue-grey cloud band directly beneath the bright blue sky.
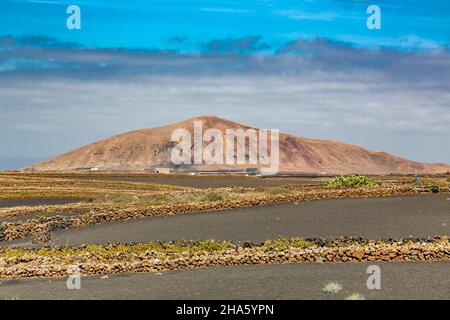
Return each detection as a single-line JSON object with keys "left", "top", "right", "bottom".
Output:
{"left": 0, "top": 36, "right": 450, "bottom": 83}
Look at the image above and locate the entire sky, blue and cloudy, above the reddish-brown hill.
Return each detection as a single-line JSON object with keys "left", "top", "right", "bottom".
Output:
{"left": 0, "top": 0, "right": 450, "bottom": 170}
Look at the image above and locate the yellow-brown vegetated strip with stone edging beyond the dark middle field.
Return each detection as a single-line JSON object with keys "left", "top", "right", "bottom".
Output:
{"left": 0, "top": 173, "right": 449, "bottom": 240}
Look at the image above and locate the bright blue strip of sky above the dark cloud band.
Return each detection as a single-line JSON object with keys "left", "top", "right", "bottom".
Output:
{"left": 0, "top": 0, "right": 450, "bottom": 51}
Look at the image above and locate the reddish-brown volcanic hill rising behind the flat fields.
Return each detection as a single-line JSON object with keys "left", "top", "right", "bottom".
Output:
{"left": 25, "top": 116, "right": 450, "bottom": 174}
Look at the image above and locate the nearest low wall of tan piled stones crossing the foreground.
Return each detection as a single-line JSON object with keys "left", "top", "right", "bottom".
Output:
{"left": 0, "top": 237, "right": 450, "bottom": 279}
